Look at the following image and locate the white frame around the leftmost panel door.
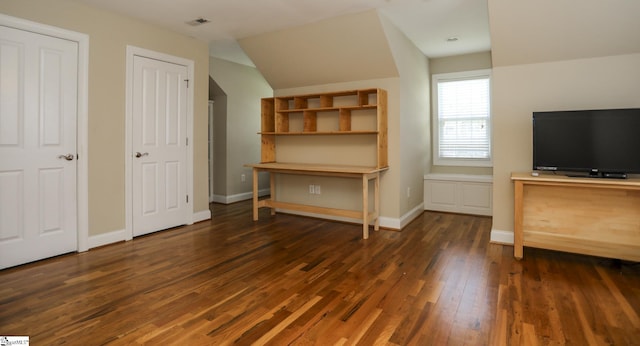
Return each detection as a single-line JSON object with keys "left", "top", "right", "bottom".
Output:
{"left": 0, "top": 13, "right": 89, "bottom": 252}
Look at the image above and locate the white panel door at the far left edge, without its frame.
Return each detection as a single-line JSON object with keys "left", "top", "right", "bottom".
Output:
{"left": 0, "top": 26, "right": 78, "bottom": 268}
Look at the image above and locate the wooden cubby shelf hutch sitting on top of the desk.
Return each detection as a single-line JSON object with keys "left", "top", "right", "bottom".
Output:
{"left": 260, "top": 88, "right": 389, "bottom": 168}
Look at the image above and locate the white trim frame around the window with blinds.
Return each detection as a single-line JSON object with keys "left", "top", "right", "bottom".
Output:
{"left": 431, "top": 69, "right": 493, "bottom": 167}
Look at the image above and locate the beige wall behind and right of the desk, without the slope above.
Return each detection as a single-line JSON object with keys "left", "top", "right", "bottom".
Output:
{"left": 264, "top": 18, "right": 429, "bottom": 220}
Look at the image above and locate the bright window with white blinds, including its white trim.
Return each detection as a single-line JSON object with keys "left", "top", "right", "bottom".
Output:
{"left": 433, "top": 70, "right": 491, "bottom": 166}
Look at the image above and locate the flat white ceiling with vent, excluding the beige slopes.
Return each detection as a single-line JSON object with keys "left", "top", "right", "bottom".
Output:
{"left": 71, "top": 0, "right": 490, "bottom": 65}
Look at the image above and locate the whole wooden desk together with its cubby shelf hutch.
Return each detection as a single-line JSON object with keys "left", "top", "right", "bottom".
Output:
{"left": 246, "top": 88, "right": 389, "bottom": 239}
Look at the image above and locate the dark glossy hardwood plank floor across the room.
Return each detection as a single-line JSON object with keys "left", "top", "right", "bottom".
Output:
{"left": 0, "top": 202, "right": 640, "bottom": 345}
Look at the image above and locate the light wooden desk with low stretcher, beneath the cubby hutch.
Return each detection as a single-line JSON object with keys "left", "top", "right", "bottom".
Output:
{"left": 245, "top": 162, "right": 388, "bottom": 239}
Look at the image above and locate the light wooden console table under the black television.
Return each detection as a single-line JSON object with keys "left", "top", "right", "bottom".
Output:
{"left": 511, "top": 173, "right": 640, "bottom": 261}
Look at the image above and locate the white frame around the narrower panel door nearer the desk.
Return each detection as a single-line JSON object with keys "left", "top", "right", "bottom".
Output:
{"left": 124, "top": 45, "right": 195, "bottom": 240}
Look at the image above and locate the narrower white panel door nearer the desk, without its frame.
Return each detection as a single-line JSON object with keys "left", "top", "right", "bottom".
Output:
{"left": 131, "top": 56, "right": 188, "bottom": 236}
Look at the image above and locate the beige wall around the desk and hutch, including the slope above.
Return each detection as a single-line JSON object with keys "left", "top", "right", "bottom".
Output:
{"left": 235, "top": 11, "right": 430, "bottom": 223}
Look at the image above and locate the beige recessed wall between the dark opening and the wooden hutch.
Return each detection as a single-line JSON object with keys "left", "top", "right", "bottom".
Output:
{"left": 209, "top": 58, "right": 273, "bottom": 197}
